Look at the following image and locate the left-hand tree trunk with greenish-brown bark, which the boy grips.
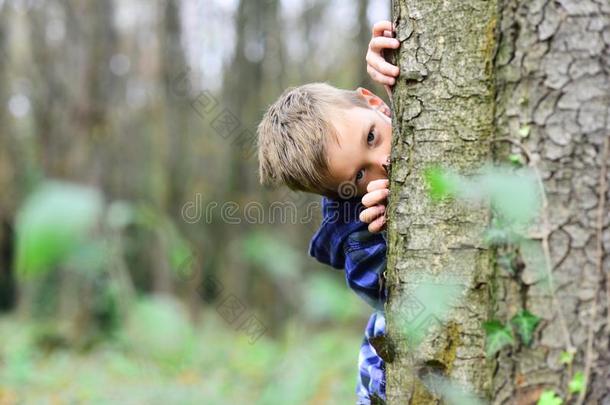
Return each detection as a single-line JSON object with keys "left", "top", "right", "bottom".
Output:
{"left": 387, "top": 0, "right": 497, "bottom": 404}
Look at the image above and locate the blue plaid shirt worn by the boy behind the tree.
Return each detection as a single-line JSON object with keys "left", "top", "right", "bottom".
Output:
{"left": 309, "top": 197, "right": 387, "bottom": 404}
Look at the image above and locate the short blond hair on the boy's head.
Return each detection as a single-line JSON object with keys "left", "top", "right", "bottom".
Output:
{"left": 258, "top": 83, "right": 369, "bottom": 197}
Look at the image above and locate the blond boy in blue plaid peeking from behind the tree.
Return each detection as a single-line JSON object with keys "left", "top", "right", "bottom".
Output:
{"left": 258, "top": 21, "right": 399, "bottom": 404}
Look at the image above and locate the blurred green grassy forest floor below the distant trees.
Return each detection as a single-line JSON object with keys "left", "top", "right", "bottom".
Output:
{"left": 0, "top": 310, "right": 364, "bottom": 405}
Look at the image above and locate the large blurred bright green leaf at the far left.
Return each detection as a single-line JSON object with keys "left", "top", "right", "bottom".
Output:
{"left": 16, "top": 181, "right": 102, "bottom": 277}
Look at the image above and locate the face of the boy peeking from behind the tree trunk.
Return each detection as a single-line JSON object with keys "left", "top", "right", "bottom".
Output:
{"left": 327, "top": 89, "right": 392, "bottom": 196}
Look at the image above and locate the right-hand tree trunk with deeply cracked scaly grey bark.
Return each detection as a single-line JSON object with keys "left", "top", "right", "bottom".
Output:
{"left": 494, "top": 0, "right": 610, "bottom": 404}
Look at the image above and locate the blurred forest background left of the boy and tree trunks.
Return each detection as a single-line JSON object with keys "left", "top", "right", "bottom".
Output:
{"left": 0, "top": 0, "right": 389, "bottom": 404}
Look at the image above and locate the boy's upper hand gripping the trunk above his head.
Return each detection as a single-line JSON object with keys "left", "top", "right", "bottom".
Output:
{"left": 366, "top": 21, "right": 400, "bottom": 93}
